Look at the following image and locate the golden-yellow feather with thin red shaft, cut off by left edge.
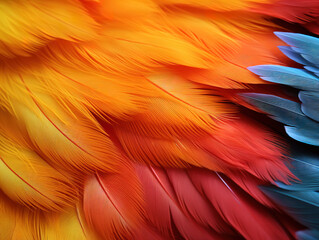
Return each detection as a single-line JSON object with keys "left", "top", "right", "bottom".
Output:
{"left": 0, "top": 133, "right": 77, "bottom": 211}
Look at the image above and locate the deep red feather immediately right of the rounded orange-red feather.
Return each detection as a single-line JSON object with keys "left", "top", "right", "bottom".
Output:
{"left": 137, "top": 166, "right": 222, "bottom": 240}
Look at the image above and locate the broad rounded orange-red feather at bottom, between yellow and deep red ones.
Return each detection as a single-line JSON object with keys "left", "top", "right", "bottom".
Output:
{"left": 83, "top": 161, "right": 143, "bottom": 239}
